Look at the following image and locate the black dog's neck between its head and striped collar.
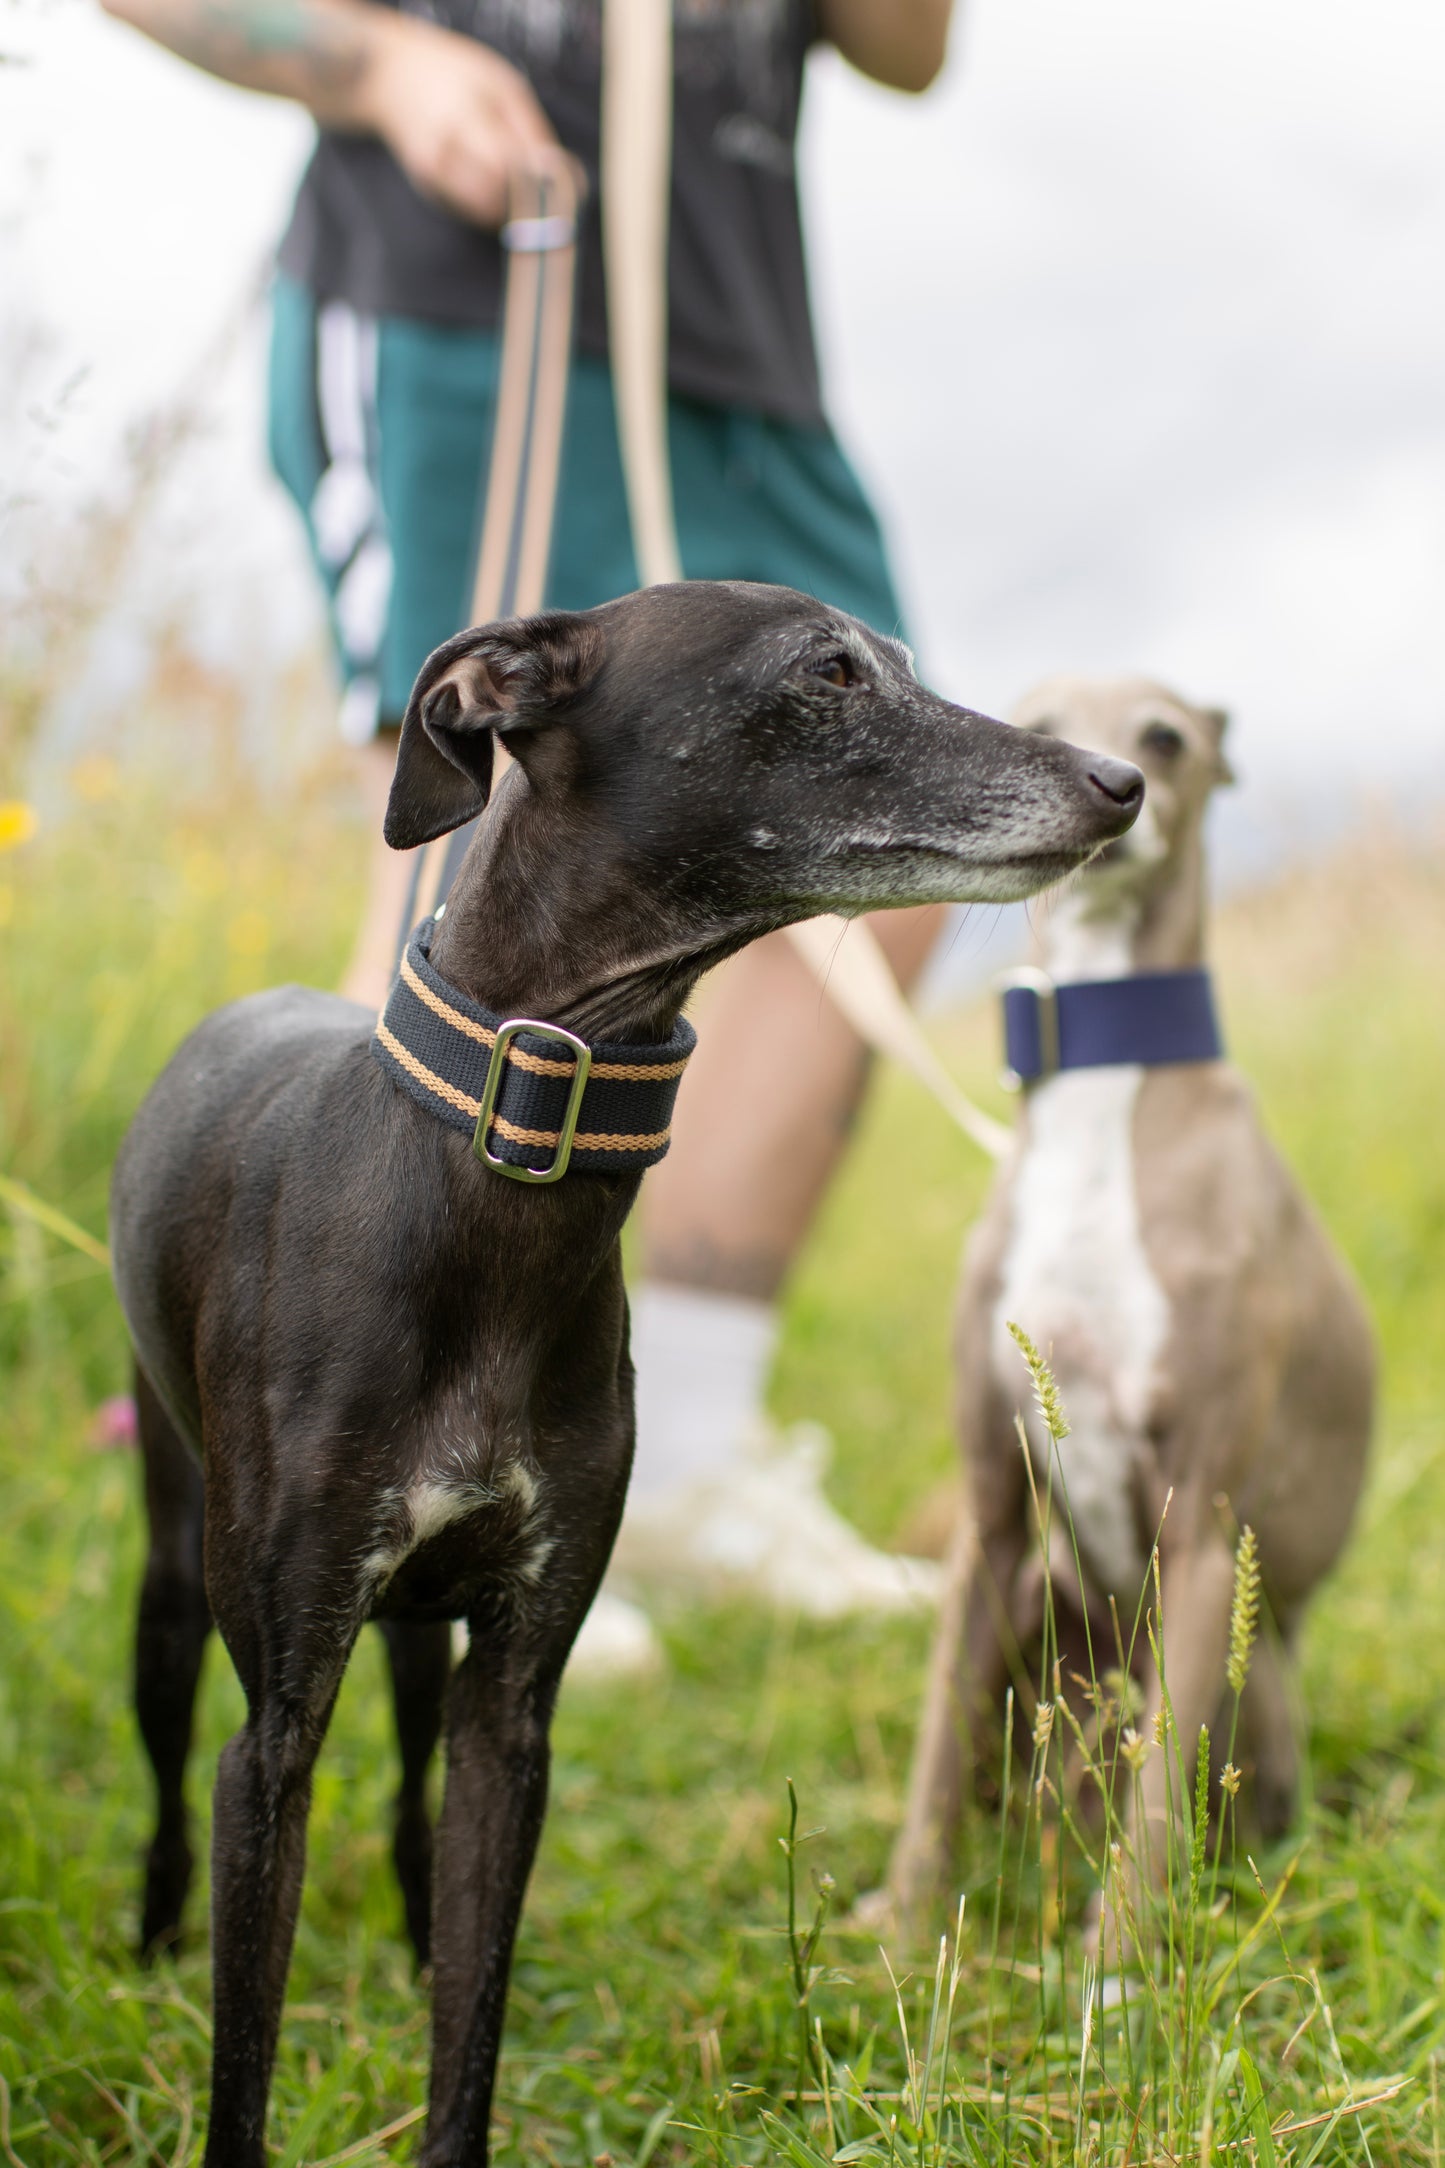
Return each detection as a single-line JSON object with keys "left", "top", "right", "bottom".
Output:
{"left": 431, "top": 776, "right": 745, "bottom": 1043}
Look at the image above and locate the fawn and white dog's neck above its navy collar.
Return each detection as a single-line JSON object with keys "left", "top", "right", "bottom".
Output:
{"left": 1040, "top": 830, "right": 1205, "bottom": 982}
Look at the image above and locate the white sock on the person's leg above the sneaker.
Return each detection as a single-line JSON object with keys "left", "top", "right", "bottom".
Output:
{"left": 630, "top": 1279, "right": 778, "bottom": 1498}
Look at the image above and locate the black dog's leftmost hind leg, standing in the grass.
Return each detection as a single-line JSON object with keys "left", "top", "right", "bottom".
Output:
{"left": 134, "top": 1364, "right": 210, "bottom": 1958}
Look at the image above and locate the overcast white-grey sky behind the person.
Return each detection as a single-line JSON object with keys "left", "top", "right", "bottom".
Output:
{"left": 0, "top": 0, "right": 1445, "bottom": 862}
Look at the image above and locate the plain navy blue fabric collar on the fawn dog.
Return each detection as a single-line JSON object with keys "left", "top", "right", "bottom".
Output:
{"left": 1003, "top": 969, "right": 1224, "bottom": 1084}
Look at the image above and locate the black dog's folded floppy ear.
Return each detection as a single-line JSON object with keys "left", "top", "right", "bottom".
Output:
{"left": 381, "top": 609, "right": 602, "bottom": 850}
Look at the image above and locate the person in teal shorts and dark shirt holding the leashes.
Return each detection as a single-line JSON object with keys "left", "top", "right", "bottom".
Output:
{"left": 104, "top": 0, "right": 951, "bottom": 1613}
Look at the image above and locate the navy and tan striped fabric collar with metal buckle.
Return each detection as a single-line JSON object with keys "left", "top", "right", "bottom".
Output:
{"left": 370, "top": 919, "right": 698, "bottom": 1182}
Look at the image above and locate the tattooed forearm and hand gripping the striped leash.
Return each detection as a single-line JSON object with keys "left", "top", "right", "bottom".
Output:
{"left": 102, "top": 0, "right": 559, "bottom": 225}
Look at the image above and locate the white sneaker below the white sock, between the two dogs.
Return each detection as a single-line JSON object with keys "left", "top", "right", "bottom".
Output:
{"left": 613, "top": 1422, "right": 942, "bottom": 1619}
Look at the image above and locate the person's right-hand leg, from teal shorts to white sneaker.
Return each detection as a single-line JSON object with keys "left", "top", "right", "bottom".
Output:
{"left": 617, "top": 401, "right": 942, "bottom": 1613}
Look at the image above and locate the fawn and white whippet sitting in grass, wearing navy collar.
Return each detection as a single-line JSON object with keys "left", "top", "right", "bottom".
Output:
{"left": 873, "top": 679, "right": 1374, "bottom": 1951}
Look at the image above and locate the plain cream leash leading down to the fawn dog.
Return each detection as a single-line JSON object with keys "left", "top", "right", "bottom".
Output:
{"left": 602, "top": 0, "right": 1012, "bottom": 1160}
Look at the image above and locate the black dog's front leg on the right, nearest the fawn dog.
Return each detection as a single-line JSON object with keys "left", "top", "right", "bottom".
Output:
{"left": 418, "top": 1633, "right": 565, "bottom": 2168}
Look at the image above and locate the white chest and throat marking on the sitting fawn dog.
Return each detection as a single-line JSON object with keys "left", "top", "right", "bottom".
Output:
{"left": 992, "top": 897, "right": 1170, "bottom": 1604}
